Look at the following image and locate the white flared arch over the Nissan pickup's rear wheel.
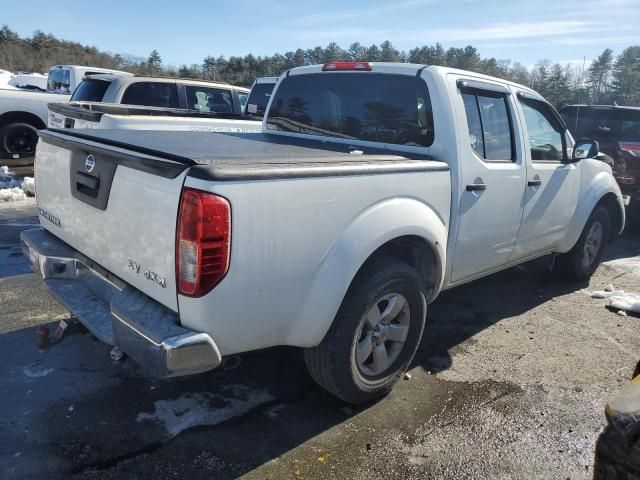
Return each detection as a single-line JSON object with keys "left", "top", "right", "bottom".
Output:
{"left": 286, "top": 198, "right": 448, "bottom": 347}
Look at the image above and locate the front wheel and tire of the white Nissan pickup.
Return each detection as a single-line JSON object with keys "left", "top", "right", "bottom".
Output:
{"left": 558, "top": 206, "right": 611, "bottom": 281}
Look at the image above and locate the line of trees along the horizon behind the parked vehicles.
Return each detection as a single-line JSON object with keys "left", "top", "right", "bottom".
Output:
{"left": 0, "top": 25, "right": 640, "bottom": 106}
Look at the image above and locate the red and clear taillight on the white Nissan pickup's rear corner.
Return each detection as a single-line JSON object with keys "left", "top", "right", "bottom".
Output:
{"left": 176, "top": 188, "right": 231, "bottom": 297}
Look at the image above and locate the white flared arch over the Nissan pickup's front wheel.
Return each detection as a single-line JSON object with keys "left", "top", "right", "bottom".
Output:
{"left": 557, "top": 171, "right": 625, "bottom": 253}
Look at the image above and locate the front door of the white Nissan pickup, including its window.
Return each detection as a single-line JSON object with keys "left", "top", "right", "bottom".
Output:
{"left": 512, "top": 92, "right": 580, "bottom": 260}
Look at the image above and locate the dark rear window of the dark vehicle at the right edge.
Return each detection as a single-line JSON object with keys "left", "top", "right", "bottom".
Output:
{"left": 560, "top": 107, "right": 640, "bottom": 142}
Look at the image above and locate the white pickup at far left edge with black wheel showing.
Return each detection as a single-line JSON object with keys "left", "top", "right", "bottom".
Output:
{"left": 0, "top": 65, "right": 130, "bottom": 158}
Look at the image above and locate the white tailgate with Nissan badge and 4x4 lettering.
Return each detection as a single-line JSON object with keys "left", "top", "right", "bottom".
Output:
{"left": 36, "top": 131, "right": 190, "bottom": 311}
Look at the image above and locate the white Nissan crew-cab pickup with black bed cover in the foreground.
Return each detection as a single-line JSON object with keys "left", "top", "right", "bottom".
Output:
{"left": 21, "top": 62, "right": 625, "bottom": 403}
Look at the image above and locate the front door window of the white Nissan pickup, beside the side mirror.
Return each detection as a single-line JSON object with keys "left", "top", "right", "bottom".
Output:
{"left": 520, "top": 98, "right": 564, "bottom": 162}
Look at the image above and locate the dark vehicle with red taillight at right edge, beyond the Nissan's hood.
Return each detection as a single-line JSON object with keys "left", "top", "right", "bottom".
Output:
{"left": 560, "top": 105, "right": 640, "bottom": 218}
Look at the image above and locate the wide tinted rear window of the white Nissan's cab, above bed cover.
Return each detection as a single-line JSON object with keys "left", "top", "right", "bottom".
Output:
{"left": 267, "top": 73, "right": 433, "bottom": 146}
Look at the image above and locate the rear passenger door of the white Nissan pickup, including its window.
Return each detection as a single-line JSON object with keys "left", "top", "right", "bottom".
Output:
{"left": 450, "top": 80, "right": 525, "bottom": 283}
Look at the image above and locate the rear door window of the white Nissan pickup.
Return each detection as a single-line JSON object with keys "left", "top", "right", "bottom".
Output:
{"left": 462, "top": 91, "right": 515, "bottom": 162}
